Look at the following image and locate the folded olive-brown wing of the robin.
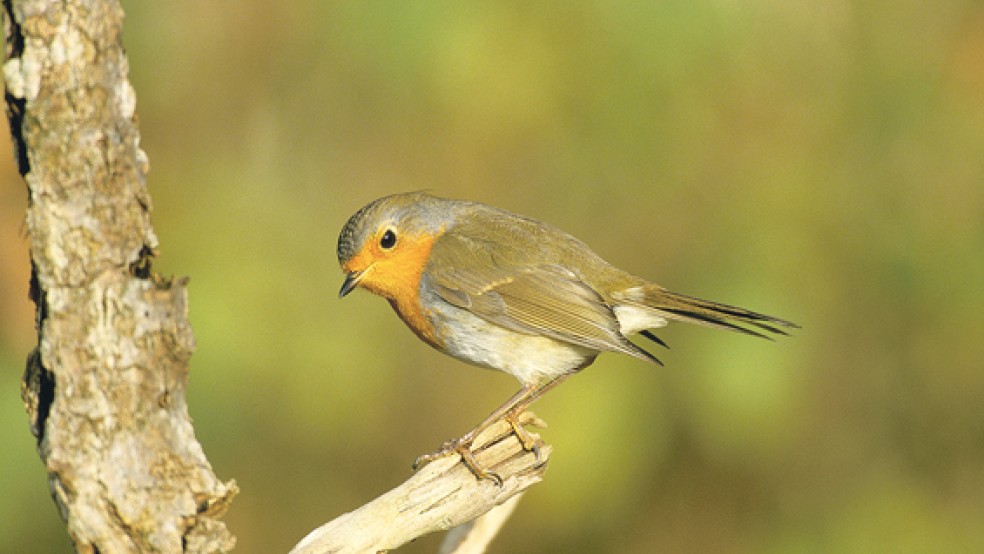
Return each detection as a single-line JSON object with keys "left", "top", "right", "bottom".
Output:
{"left": 427, "top": 232, "right": 660, "bottom": 364}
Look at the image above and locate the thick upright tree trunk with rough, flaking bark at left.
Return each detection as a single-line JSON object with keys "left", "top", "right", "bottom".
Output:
{"left": 3, "top": 0, "right": 237, "bottom": 553}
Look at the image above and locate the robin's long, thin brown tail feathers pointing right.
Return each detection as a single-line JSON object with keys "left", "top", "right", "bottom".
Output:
{"left": 645, "top": 289, "right": 799, "bottom": 340}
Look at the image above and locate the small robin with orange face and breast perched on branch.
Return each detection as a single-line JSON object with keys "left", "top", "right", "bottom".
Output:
{"left": 338, "top": 192, "right": 797, "bottom": 481}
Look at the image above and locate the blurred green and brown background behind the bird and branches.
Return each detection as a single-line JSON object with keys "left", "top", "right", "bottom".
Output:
{"left": 0, "top": 0, "right": 984, "bottom": 553}
